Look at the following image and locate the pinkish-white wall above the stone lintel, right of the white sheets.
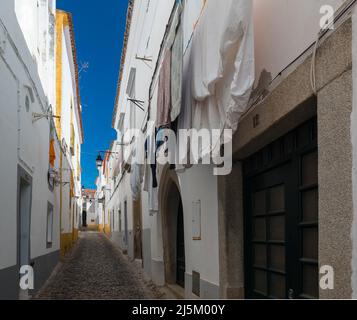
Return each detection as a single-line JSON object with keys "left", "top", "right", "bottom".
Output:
{"left": 253, "top": 0, "right": 345, "bottom": 81}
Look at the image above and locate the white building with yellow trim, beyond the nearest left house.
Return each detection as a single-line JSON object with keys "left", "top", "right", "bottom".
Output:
{"left": 54, "top": 10, "right": 84, "bottom": 256}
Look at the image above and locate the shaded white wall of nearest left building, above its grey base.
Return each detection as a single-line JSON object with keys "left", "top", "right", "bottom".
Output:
{"left": 0, "top": 0, "right": 59, "bottom": 269}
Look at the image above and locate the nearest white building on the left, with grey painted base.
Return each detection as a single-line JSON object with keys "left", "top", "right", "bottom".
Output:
{"left": 0, "top": 0, "right": 80, "bottom": 299}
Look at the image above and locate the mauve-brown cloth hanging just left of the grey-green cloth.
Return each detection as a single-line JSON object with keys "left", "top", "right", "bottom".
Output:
{"left": 156, "top": 50, "right": 171, "bottom": 127}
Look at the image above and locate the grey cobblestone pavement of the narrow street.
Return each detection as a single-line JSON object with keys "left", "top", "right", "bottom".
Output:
{"left": 36, "top": 232, "right": 163, "bottom": 299}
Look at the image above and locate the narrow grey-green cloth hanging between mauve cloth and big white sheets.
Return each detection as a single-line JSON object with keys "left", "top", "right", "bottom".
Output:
{"left": 171, "top": 26, "right": 183, "bottom": 122}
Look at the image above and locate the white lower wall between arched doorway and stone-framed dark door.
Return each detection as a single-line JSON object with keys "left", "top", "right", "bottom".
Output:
{"left": 179, "top": 165, "right": 219, "bottom": 292}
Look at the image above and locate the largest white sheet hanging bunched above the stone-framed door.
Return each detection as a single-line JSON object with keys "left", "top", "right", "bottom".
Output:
{"left": 191, "top": 0, "right": 255, "bottom": 131}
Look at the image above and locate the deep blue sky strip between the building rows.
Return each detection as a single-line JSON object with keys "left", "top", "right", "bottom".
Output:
{"left": 57, "top": 0, "right": 128, "bottom": 188}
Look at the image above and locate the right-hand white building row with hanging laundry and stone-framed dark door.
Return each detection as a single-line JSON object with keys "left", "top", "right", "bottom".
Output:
{"left": 105, "top": 0, "right": 357, "bottom": 298}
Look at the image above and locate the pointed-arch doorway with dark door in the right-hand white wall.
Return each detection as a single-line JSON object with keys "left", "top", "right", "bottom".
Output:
{"left": 161, "top": 169, "right": 186, "bottom": 288}
